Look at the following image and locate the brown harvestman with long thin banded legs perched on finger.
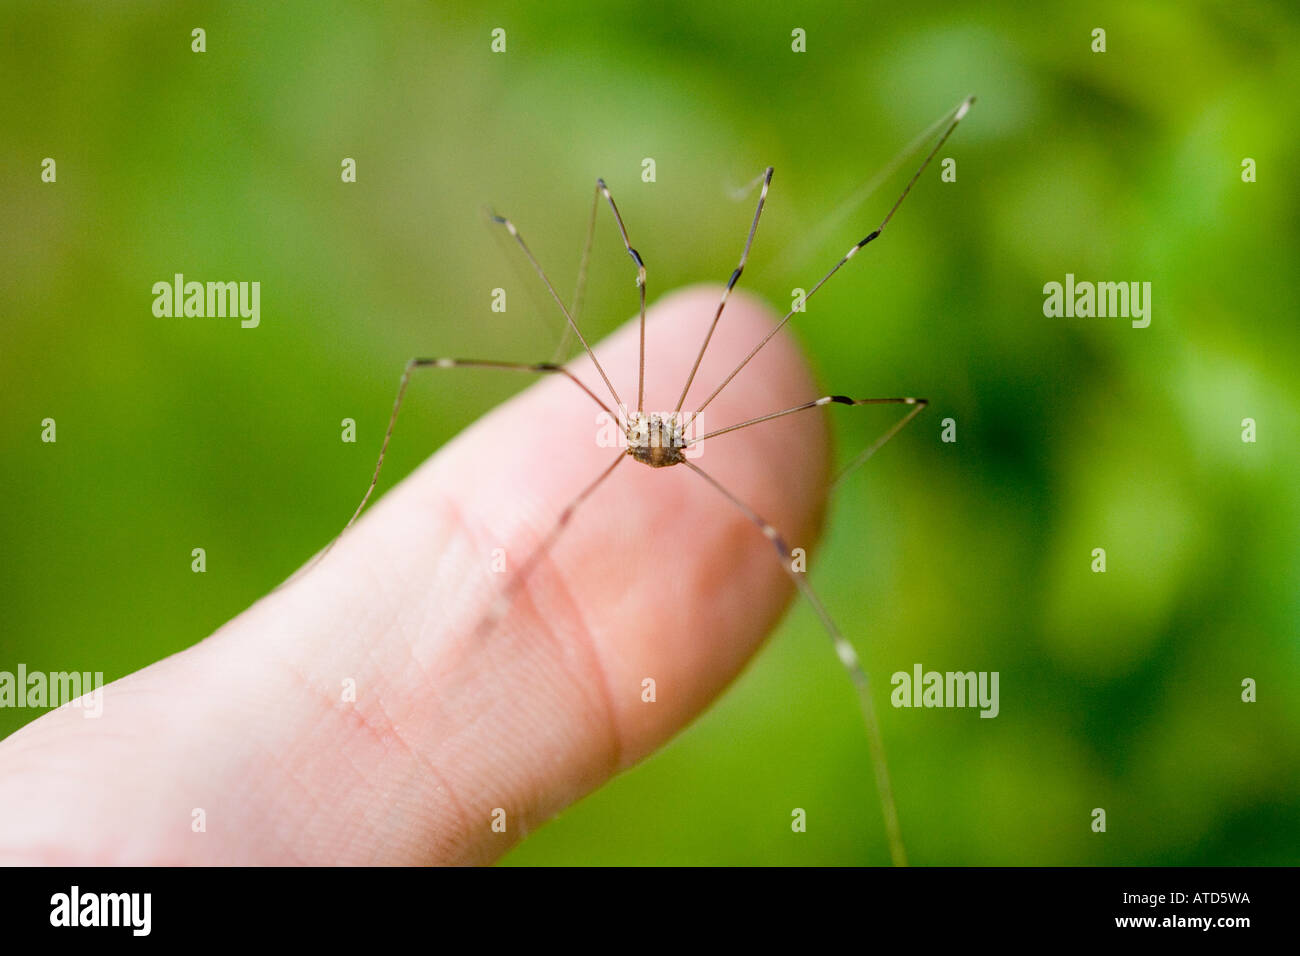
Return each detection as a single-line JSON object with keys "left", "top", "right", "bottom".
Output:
{"left": 325, "top": 96, "right": 975, "bottom": 865}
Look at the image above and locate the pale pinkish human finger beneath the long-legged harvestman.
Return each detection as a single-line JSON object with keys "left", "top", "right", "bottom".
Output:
{"left": 0, "top": 286, "right": 832, "bottom": 865}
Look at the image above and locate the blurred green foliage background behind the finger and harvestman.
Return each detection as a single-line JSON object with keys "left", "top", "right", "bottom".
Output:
{"left": 0, "top": 0, "right": 1300, "bottom": 864}
